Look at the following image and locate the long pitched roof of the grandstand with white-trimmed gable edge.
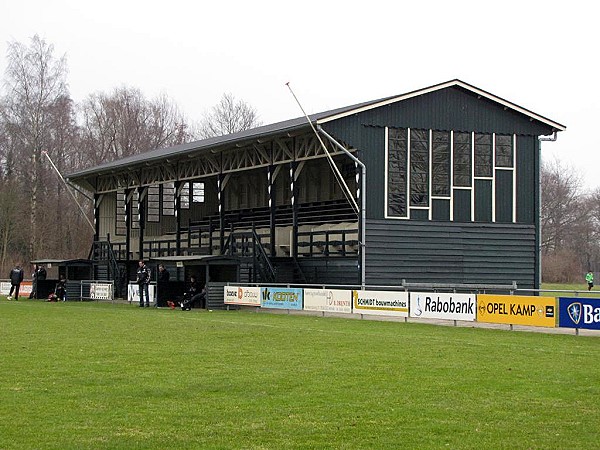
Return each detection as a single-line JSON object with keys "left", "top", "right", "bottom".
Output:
{"left": 67, "top": 79, "right": 566, "bottom": 179}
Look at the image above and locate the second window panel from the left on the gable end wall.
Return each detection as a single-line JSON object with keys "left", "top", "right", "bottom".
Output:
{"left": 410, "top": 130, "right": 429, "bottom": 206}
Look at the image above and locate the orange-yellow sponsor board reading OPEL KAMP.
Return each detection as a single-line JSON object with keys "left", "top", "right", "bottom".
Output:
{"left": 477, "top": 294, "right": 556, "bottom": 327}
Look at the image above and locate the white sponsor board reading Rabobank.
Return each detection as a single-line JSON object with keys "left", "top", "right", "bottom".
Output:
{"left": 410, "top": 292, "right": 477, "bottom": 321}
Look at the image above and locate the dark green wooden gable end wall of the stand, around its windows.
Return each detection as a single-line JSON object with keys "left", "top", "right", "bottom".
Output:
{"left": 322, "top": 87, "right": 553, "bottom": 288}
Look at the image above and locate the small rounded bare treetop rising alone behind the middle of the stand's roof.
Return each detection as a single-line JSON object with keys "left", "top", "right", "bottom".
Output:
{"left": 199, "top": 94, "right": 262, "bottom": 139}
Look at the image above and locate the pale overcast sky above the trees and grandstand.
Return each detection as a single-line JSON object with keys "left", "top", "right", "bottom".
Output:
{"left": 0, "top": 0, "right": 600, "bottom": 189}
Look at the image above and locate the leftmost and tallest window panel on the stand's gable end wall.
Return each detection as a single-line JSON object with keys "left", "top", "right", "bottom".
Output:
{"left": 387, "top": 128, "right": 408, "bottom": 217}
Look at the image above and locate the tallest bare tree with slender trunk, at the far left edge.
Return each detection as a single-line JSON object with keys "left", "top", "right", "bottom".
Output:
{"left": 0, "top": 35, "right": 69, "bottom": 258}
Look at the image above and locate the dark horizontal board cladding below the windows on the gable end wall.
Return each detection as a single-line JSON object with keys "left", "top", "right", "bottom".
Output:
{"left": 366, "top": 220, "right": 535, "bottom": 288}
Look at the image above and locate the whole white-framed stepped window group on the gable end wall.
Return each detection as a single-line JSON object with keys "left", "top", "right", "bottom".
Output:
{"left": 384, "top": 128, "right": 517, "bottom": 223}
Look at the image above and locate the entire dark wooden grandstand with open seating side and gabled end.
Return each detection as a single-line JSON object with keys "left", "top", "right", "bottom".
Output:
{"left": 68, "top": 80, "right": 565, "bottom": 296}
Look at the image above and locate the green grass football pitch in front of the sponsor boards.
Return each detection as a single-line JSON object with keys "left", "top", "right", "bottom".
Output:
{"left": 0, "top": 297, "right": 600, "bottom": 449}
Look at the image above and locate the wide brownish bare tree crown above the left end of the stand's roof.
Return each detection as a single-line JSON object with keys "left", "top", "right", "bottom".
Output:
{"left": 81, "top": 87, "right": 191, "bottom": 164}
